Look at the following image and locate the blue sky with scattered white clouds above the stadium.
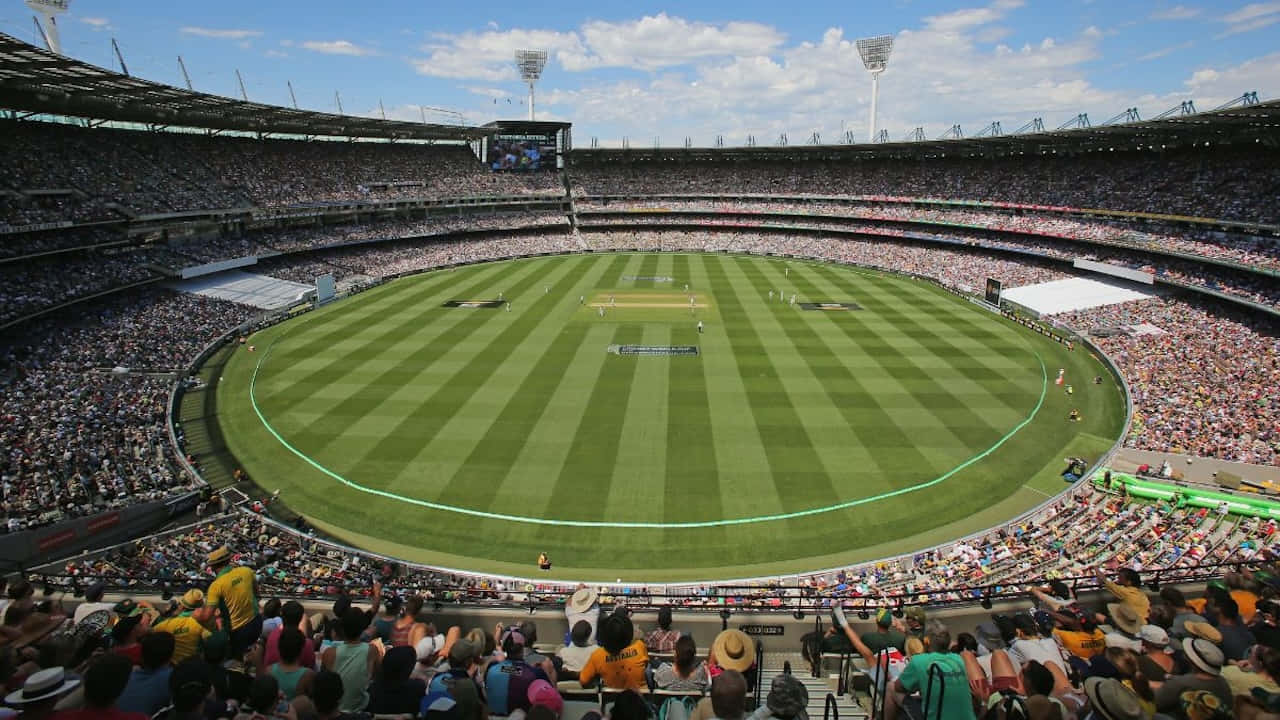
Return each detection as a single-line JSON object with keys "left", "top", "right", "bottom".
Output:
{"left": 0, "top": 0, "right": 1280, "bottom": 145}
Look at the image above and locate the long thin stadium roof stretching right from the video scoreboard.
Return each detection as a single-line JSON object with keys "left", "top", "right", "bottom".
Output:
{"left": 572, "top": 100, "right": 1280, "bottom": 163}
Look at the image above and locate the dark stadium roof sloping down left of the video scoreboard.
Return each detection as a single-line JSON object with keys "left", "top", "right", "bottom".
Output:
{"left": 0, "top": 33, "right": 486, "bottom": 141}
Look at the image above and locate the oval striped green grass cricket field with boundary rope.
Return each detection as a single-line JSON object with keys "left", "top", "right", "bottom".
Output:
{"left": 218, "top": 254, "right": 1124, "bottom": 580}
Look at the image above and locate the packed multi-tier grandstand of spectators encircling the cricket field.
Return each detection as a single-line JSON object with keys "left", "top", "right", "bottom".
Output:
{"left": 0, "top": 12, "right": 1280, "bottom": 720}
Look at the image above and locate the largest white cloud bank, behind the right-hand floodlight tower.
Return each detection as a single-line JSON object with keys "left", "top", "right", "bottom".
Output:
{"left": 529, "top": 0, "right": 1132, "bottom": 143}
